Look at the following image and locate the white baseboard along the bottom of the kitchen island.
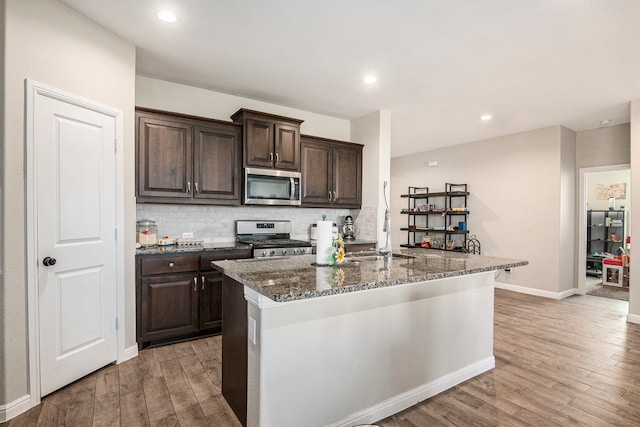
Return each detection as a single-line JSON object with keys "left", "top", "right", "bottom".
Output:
{"left": 335, "top": 356, "right": 496, "bottom": 427}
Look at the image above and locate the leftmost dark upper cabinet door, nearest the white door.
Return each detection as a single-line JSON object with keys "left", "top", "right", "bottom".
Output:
{"left": 136, "top": 113, "right": 192, "bottom": 198}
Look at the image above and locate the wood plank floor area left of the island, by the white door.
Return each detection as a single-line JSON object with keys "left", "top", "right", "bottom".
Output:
{"left": 3, "top": 336, "right": 240, "bottom": 427}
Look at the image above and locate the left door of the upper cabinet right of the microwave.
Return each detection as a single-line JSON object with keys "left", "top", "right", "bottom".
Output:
{"left": 300, "top": 139, "right": 332, "bottom": 206}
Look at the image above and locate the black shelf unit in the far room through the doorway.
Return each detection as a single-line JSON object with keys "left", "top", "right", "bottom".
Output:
{"left": 587, "top": 209, "right": 625, "bottom": 276}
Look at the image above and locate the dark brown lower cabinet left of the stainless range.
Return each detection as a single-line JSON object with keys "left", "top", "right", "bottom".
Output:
{"left": 136, "top": 249, "right": 251, "bottom": 348}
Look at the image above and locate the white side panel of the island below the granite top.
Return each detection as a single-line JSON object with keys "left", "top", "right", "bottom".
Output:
{"left": 244, "top": 272, "right": 495, "bottom": 427}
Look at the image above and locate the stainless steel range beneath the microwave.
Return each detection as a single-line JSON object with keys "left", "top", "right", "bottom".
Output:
{"left": 236, "top": 220, "right": 312, "bottom": 258}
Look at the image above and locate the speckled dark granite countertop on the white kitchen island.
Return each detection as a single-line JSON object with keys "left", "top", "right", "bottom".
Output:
{"left": 214, "top": 248, "right": 529, "bottom": 302}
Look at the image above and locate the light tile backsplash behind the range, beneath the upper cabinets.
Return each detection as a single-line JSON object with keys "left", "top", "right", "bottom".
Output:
{"left": 136, "top": 203, "right": 377, "bottom": 242}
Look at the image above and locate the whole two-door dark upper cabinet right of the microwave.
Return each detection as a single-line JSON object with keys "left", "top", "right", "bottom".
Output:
{"left": 300, "top": 135, "right": 363, "bottom": 208}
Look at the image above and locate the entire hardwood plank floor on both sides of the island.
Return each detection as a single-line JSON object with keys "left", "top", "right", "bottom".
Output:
{"left": 6, "top": 289, "right": 640, "bottom": 427}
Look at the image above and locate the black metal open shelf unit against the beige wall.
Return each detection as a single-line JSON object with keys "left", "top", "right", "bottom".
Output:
{"left": 400, "top": 183, "right": 469, "bottom": 251}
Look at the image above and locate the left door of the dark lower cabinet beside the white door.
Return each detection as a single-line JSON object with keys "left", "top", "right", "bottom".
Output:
{"left": 139, "top": 272, "right": 199, "bottom": 342}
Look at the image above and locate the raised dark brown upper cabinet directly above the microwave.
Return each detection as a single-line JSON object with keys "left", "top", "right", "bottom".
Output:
{"left": 231, "top": 108, "right": 303, "bottom": 171}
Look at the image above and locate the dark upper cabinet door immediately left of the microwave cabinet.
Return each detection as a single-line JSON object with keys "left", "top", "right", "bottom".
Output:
{"left": 193, "top": 124, "right": 242, "bottom": 203}
